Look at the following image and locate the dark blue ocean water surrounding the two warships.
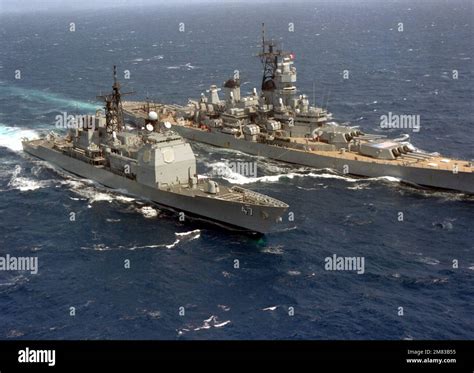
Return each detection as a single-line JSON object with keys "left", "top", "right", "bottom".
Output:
{"left": 0, "top": 1, "right": 474, "bottom": 339}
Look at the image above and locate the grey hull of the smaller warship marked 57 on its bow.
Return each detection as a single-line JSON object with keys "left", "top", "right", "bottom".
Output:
{"left": 23, "top": 140, "right": 287, "bottom": 234}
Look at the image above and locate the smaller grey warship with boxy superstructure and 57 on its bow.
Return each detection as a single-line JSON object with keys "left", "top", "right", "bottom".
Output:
{"left": 22, "top": 67, "right": 288, "bottom": 234}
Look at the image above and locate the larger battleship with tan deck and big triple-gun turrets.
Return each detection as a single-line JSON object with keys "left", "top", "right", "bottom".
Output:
{"left": 124, "top": 25, "right": 474, "bottom": 194}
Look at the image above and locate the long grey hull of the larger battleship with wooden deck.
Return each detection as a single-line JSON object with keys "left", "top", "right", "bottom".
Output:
{"left": 168, "top": 125, "right": 474, "bottom": 194}
